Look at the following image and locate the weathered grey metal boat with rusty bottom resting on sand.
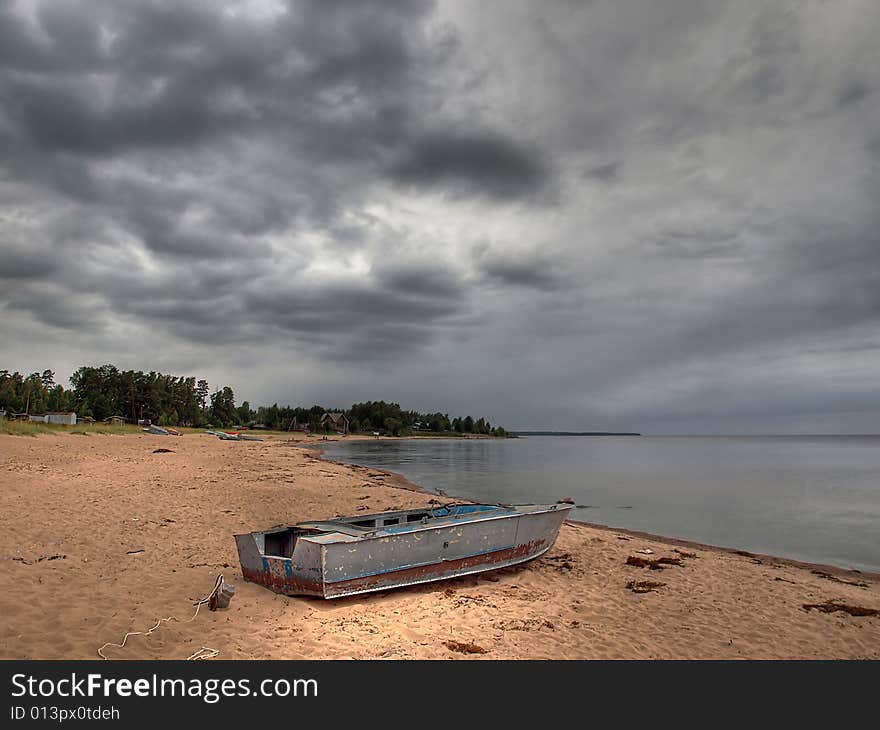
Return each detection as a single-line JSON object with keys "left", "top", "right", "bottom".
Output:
{"left": 235, "top": 503, "right": 572, "bottom": 598}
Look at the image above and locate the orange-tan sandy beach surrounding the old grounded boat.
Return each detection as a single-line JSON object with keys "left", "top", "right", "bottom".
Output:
{"left": 0, "top": 434, "right": 880, "bottom": 659}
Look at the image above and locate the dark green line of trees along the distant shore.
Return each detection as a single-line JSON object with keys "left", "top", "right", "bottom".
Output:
{"left": 0, "top": 365, "right": 507, "bottom": 436}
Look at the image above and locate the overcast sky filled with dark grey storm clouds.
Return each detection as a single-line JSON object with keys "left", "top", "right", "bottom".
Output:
{"left": 0, "top": 0, "right": 880, "bottom": 433}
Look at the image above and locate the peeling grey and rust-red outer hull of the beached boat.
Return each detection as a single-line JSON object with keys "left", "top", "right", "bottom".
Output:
{"left": 236, "top": 505, "right": 570, "bottom": 598}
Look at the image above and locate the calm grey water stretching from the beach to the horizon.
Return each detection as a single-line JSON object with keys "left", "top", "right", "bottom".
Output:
{"left": 324, "top": 436, "right": 880, "bottom": 571}
